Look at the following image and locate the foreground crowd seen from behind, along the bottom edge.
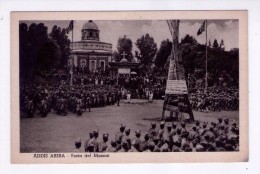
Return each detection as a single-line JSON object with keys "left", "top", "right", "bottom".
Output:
{"left": 73, "top": 118, "right": 239, "bottom": 152}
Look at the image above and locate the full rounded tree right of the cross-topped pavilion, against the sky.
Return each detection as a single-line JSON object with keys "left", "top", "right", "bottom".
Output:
{"left": 135, "top": 34, "right": 157, "bottom": 69}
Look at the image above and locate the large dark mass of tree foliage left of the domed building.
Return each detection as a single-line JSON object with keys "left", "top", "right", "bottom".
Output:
{"left": 19, "top": 23, "right": 70, "bottom": 79}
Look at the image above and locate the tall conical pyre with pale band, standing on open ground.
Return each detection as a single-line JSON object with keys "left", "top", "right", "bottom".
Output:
{"left": 162, "top": 20, "right": 194, "bottom": 121}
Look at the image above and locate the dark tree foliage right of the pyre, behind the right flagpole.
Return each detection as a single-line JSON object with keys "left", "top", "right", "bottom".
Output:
{"left": 180, "top": 34, "right": 239, "bottom": 85}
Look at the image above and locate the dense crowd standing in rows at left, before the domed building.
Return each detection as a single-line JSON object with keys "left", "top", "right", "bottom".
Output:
{"left": 20, "top": 84, "right": 122, "bottom": 117}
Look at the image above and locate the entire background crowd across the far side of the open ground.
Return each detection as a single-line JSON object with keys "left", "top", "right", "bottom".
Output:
{"left": 20, "top": 67, "right": 239, "bottom": 117}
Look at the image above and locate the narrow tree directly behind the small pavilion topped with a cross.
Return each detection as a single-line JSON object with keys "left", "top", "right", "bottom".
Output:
{"left": 117, "top": 35, "right": 133, "bottom": 62}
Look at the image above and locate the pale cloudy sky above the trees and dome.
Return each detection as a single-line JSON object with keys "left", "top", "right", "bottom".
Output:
{"left": 20, "top": 19, "right": 239, "bottom": 52}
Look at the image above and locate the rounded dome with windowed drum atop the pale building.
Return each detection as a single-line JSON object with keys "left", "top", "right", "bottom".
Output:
{"left": 81, "top": 20, "right": 99, "bottom": 41}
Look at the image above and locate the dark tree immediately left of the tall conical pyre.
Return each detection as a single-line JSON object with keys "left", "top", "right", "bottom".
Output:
{"left": 154, "top": 39, "right": 172, "bottom": 68}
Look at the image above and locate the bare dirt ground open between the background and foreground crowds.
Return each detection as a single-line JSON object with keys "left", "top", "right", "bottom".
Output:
{"left": 20, "top": 100, "right": 239, "bottom": 153}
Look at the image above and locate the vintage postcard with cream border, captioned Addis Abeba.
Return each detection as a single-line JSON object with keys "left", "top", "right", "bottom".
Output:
{"left": 11, "top": 11, "right": 249, "bottom": 164}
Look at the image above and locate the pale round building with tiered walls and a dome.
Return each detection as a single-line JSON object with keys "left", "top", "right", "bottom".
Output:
{"left": 69, "top": 20, "right": 112, "bottom": 72}
